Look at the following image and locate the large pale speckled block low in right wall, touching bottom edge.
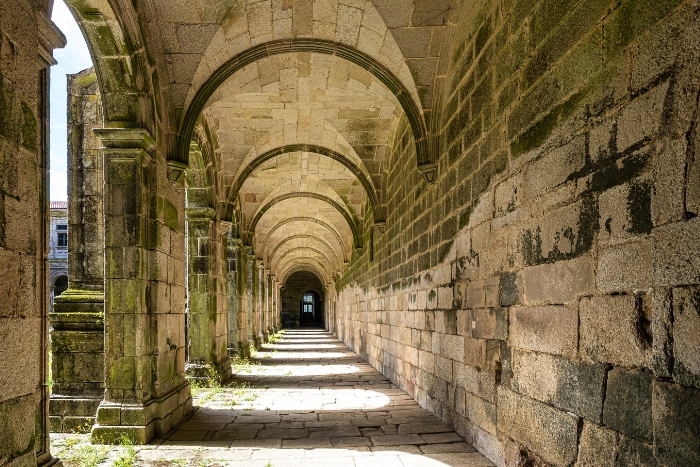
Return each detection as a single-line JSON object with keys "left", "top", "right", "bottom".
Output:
{"left": 498, "top": 387, "right": 578, "bottom": 465}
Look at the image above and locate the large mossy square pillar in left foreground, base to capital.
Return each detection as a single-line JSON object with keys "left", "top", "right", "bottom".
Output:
{"left": 92, "top": 129, "right": 192, "bottom": 444}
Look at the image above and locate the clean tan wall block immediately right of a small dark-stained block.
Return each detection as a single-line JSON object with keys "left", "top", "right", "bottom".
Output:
{"left": 524, "top": 256, "right": 595, "bottom": 304}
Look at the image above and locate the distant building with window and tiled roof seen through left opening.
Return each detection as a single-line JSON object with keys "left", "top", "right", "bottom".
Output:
{"left": 49, "top": 201, "right": 68, "bottom": 309}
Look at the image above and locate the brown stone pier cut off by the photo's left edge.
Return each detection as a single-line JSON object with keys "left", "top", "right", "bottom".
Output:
{"left": 0, "top": 0, "right": 65, "bottom": 465}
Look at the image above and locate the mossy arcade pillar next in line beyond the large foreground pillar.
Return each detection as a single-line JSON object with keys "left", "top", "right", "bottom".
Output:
{"left": 185, "top": 207, "right": 231, "bottom": 382}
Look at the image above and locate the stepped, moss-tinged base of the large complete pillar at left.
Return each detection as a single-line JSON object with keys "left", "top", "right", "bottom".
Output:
{"left": 91, "top": 383, "right": 192, "bottom": 444}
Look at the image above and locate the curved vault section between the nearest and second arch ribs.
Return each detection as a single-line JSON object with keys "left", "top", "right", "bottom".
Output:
{"left": 207, "top": 53, "right": 402, "bottom": 188}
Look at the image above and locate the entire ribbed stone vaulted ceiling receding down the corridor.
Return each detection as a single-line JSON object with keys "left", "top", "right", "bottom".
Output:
{"left": 69, "top": 0, "right": 454, "bottom": 288}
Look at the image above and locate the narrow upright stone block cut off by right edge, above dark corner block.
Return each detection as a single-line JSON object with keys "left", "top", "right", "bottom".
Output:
{"left": 673, "top": 286, "right": 700, "bottom": 387}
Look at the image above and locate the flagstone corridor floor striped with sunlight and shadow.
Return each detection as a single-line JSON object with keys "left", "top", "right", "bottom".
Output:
{"left": 54, "top": 330, "right": 493, "bottom": 467}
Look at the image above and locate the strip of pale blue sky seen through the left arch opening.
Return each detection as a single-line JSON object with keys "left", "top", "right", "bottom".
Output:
{"left": 50, "top": 0, "right": 92, "bottom": 201}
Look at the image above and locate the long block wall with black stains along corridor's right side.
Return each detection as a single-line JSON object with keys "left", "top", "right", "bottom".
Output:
{"left": 335, "top": 0, "right": 700, "bottom": 466}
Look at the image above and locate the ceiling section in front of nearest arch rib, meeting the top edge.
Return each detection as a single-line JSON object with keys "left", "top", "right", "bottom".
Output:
{"left": 173, "top": 0, "right": 420, "bottom": 108}
